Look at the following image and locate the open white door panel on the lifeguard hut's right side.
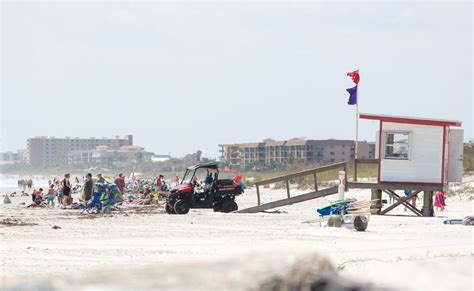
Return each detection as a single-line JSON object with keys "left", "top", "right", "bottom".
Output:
{"left": 448, "top": 129, "right": 464, "bottom": 182}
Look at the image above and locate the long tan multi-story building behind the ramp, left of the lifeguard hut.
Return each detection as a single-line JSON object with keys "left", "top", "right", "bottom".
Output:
{"left": 219, "top": 139, "right": 375, "bottom": 167}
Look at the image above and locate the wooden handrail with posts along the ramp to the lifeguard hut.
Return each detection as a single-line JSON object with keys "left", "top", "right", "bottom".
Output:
{"left": 255, "top": 162, "right": 347, "bottom": 206}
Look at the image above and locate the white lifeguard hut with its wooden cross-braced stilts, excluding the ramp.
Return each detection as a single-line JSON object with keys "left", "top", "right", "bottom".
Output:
{"left": 349, "top": 113, "right": 464, "bottom": 216}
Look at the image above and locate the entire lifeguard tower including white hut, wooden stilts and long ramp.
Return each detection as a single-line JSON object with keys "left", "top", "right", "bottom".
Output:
{"left": 239, "top": 113, "right": 463, "bottom": 216}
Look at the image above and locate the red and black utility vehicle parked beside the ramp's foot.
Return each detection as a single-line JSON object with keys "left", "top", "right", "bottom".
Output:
{"left": 166, "top": 163, "right": 244, "bottom": 214}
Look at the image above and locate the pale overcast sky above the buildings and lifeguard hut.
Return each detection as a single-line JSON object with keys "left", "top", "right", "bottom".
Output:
{"left": 0, "top": 1, "right": 474, "bottom": 157}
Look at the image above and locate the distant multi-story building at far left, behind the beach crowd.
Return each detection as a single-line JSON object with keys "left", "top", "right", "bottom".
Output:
{"left": 26, "top": 135, "right": 133, "bottom": 167}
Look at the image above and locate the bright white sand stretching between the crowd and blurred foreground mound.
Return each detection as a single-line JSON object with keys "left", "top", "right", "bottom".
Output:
{"left": 0, "top": 177, "right": 474, "bottom": 290}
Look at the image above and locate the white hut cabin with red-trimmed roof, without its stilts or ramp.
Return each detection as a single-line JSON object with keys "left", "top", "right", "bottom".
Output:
{"left": 360, "top": 113, "right": 463, "bottom": 185}
